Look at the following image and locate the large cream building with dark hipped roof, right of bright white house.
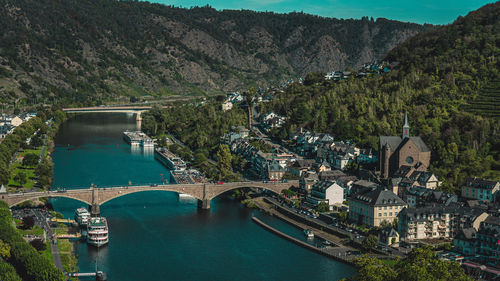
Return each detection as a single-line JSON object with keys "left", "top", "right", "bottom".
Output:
{"left": 349, "top": 188, "right": 407, "bottom": 227}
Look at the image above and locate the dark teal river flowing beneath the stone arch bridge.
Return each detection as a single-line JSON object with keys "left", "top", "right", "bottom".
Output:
{"left": 52, "top": 113, "right": 356, "bottom": 281}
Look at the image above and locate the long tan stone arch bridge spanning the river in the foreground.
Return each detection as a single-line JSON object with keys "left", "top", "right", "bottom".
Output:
{"left": 0, "top": 181, "right": 298, "bottom": 213}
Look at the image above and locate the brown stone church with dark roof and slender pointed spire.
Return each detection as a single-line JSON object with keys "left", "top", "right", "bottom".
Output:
{"left": 379, "top": 114, "right": 431, "bottom": 179}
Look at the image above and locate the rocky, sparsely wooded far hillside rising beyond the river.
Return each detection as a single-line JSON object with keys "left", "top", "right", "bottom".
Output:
{"left": 0, "top": 0, "right": 431, "bottom": 104}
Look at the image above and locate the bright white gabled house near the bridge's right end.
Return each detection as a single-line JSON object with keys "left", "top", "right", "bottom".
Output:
{"left": 306, "top": 181, "right": 344, "bottom": 210}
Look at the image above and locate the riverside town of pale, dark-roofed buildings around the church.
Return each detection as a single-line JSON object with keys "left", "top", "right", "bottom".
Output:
{"left": 221, "top": 90, "right": 500, "bottom": 279}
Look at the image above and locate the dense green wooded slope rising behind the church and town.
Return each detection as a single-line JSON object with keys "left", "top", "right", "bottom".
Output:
{"left": 262, "top": 2, "right": 500, "bottom": 189}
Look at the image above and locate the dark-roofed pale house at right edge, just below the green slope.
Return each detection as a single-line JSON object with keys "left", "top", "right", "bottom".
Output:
{"left": 461, "top": 178, "right": 500, "bottom": 202}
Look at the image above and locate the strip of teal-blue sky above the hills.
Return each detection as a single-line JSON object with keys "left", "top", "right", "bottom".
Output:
{"left": 149, "top": 0, "right": 495, "bottom": 24}
